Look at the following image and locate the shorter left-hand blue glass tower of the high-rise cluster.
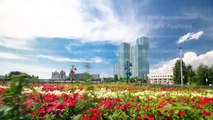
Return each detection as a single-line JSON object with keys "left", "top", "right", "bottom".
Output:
{"left": 117, "top": 43, "right": 130, "bottom": 77}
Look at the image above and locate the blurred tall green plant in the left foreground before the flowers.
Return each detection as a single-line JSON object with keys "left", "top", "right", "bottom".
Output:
{"left": 0, "top": 73, "right": 34, "bottom": 120}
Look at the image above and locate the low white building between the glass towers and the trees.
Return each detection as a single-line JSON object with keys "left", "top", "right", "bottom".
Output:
{"left": 148, "top": 74, "right": 174, "bottom": 85}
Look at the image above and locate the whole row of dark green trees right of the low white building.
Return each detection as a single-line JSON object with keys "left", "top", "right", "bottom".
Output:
{"left": 173, "top": 60, "right": 213, "bottom": 85}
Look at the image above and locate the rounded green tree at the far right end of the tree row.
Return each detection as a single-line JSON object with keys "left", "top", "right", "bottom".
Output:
{"left": 196, "top": 65, "right": 211, "bottom": 85}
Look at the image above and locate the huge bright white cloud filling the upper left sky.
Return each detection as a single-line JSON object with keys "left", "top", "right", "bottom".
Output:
{"left": 0, "top": 0, "right": 146, "bottom": 49}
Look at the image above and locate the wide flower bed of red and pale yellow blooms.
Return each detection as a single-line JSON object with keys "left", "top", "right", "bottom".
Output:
{"left": 0, "top": 84, "right": 213, "bottom": 120}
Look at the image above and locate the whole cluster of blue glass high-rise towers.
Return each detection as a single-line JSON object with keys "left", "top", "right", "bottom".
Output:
{"left": 114, "top": 37, "right": 149, "bottom": 78}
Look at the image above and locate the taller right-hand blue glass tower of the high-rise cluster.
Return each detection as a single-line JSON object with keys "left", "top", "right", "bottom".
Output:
{"left": 130, "top": 37, "right": 149, "bottom": 78}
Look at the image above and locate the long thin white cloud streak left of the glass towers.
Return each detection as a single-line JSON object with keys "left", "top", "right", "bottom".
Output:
{"left": 37, "top": 55, "right": 103, "bottom": 63}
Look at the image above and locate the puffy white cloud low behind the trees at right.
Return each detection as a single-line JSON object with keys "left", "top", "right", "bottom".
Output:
{"left": 150, "top": 50, "right": 213, "bottom": 74}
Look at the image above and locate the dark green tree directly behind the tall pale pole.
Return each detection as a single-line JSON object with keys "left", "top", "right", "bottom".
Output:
{"left": 173, "top": 60, "right": 187, "bottom": 84}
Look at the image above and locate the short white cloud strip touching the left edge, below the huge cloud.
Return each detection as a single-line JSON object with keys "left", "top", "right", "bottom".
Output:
{"left": 0, "top": 52, "right": 25, "bottom": 59}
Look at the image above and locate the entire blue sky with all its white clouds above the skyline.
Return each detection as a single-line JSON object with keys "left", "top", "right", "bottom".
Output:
{"left": 0, "top": 0, "right": 213, "bottom": 78}
